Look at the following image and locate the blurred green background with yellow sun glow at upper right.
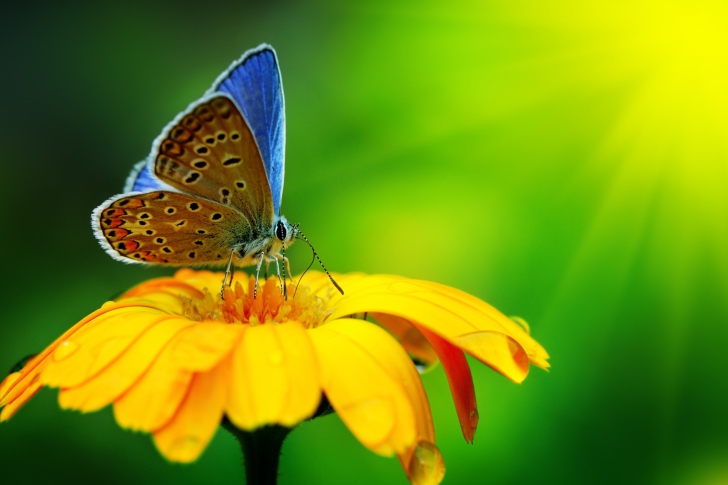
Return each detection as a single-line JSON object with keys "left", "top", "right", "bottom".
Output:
{"left": 0, "top": 0, "right": 728, "bottom": 484}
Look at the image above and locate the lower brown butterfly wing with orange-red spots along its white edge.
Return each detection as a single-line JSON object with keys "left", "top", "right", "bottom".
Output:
{"left": 91, "top": 191, "right": 253, "bottom": 265}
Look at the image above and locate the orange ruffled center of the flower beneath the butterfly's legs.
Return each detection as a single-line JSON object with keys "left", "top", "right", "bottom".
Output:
{"left": 184, "top": 276, "right": 330, "bottom": 328}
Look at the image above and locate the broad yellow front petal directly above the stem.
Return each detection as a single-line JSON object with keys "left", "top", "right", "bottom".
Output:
{"left": 226, "top": 322, "right": 321, "bottom": 430}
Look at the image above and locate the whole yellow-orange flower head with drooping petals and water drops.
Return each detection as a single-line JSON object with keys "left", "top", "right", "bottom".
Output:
{"left": 0, "top": 269, "right": 548, "bottom": 484}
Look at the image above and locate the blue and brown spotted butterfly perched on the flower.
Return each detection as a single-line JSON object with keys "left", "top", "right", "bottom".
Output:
{"left": 91, "top": 44, "right": 343, "bottom": 294}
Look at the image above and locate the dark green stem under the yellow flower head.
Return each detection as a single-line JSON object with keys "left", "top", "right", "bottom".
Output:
{"left": 222, "top": 418, "right": 292, "bottom": 485}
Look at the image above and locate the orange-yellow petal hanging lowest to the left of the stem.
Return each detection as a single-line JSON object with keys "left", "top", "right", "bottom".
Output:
{"left": 154, "top": 358, "right": 230, "bottom": 463}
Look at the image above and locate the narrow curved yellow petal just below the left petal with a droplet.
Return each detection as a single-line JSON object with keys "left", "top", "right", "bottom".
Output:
{"left": 58, "top": 317, "right": 198, "bottom": 412}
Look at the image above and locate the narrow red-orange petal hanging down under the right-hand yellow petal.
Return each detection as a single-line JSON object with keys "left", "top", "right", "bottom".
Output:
{"left": 422, "top": 328, "right": 478, "bottom": 443}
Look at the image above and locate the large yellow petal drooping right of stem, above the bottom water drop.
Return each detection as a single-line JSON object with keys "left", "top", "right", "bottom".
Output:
{"left": 309, "top": 319, "right": 420, "bottom": 455}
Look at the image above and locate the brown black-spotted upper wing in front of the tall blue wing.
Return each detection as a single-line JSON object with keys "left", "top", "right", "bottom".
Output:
{"left": 152, "top": 93, "right": 274, "bottom": 232}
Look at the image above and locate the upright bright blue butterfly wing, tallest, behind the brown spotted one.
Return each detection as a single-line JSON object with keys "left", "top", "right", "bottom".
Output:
{"left": 208, "top": 44, "right": 286, "bottom": 214}
